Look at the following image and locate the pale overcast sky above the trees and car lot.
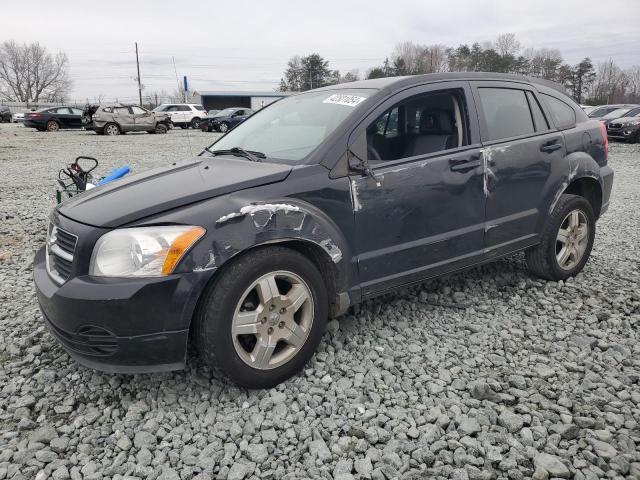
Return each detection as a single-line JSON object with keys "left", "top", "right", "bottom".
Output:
{"left": 0, "top": 0, "right": 640, "bottom": 101}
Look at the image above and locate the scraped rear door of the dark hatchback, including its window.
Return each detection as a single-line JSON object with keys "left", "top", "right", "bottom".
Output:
{"left": 472, "top": 81, "right": 566, "bottom": 257}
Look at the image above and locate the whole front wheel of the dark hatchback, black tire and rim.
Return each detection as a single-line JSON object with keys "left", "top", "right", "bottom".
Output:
{"left": 193, "top": 246, "right": 328, "bottom": 388}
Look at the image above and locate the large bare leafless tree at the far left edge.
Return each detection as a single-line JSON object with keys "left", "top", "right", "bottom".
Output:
{"left": 0, "top": 40, "right": 71, "bottom": 102}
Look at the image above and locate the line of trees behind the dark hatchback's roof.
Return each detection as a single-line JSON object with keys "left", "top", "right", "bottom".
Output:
{"left": 280, "top": 33, "right": 640, "bottom": 105}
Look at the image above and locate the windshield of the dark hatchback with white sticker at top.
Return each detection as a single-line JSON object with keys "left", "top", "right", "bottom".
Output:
{"left": 212, "top": 89, "right": 374, "bottom": 162}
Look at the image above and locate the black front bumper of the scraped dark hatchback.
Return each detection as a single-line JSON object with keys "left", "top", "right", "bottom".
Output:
{"left": 33, "top": 248, "right": 212, "bottom": 373}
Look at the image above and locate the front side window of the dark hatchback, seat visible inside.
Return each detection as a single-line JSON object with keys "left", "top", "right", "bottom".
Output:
{"left": 367, "top": 90, "right": 467, "bottom": 162}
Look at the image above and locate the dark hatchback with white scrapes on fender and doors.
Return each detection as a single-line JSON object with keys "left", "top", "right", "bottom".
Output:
{"left": 34, "top": 73, "right": 613, "bottom": 387}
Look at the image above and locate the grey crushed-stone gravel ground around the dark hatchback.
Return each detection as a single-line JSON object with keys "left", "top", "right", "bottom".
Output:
{"left": 0, "top": 124, "right": 640, "bottom": 480}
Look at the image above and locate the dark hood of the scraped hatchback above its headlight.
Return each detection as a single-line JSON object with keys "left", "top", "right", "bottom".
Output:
{"left": 57, "top": 156, "right": 291, "bottom": 228}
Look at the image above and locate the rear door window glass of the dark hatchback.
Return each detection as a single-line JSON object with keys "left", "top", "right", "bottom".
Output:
{"left": 478, "top": 88, "right": 534, "bottom": 140}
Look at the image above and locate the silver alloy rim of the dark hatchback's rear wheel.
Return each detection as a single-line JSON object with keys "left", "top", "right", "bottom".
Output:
{"left": 556, "top": 209, "right": 589, "bottom": 270}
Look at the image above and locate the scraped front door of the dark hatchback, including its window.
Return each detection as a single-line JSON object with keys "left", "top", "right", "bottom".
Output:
{"left": 350, "top": 82, "right": 485, "bottom": 297}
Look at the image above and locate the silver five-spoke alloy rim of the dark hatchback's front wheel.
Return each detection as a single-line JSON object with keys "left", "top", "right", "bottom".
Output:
{"left": 231, "top": 271, "right": 314, "bottom": 370}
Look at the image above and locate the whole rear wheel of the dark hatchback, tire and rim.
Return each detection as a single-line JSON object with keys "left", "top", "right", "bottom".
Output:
{"left": 525, "top": 194, "right": 596, "bottom": 281}
